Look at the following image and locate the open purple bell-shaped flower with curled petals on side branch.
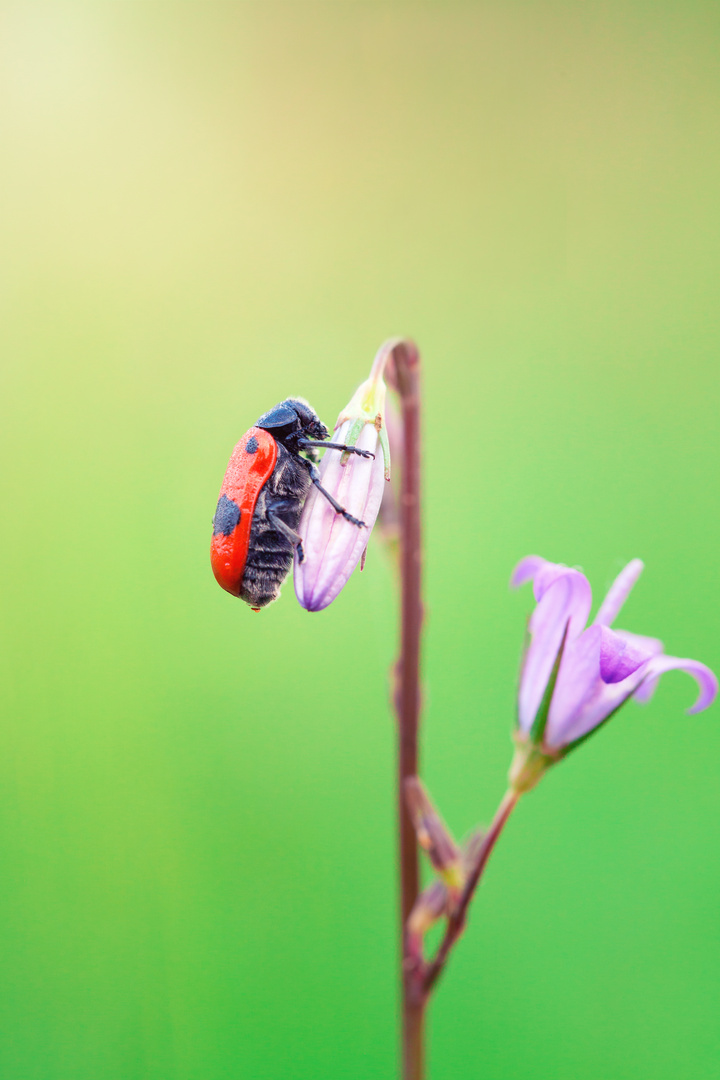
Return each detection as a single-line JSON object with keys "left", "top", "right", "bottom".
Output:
{"left": 511, "top": 555, "right": 718, "bottom": 789}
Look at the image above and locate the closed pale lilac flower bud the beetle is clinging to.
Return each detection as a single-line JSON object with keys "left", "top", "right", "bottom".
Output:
{"left": 294, "top": 341, "right": 396, "bottom": 611}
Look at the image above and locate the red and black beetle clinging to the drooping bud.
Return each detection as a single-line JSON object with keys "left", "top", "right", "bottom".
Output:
{"left": 210, "top": 397, "right": 375, "bottom": 611}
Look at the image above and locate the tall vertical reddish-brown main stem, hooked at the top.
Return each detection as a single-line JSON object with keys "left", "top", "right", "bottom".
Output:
{"left": 389, "top": 341, "right": 425, "bottom": 1080}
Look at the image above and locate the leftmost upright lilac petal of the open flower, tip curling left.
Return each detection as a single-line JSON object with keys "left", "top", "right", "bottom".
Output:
{"left": 518, "top": 563, "right": 593, "bottom": 734}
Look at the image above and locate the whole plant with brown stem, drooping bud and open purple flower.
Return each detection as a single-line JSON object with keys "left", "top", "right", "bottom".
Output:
{"left": 295, "top": 338, "right": 718, "bottom": 1080}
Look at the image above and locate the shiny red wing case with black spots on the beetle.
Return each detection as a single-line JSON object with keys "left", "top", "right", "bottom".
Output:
{"left": 210, "top": 428, "right": 277, "bottom": 596}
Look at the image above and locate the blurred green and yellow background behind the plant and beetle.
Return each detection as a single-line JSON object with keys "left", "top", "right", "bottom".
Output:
{"left": 0, "top": 0, "right": 720, "bottom": 1080}
